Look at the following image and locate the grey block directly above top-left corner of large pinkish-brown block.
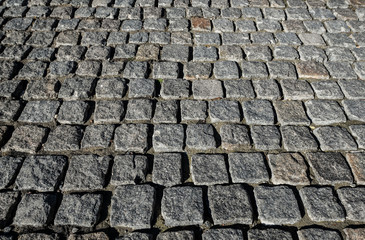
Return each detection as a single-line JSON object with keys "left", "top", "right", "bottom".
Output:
{"left": 251, "top": 125, "right": 281, "bottom": 150}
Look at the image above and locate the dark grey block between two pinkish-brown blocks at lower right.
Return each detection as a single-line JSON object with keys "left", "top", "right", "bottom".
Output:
{"left": 306, "top": 152, "right": 353, "bottom": 185}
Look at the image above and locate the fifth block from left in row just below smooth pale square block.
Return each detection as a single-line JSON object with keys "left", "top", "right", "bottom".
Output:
{"left": 125, "top": 99, "right": 152, "bottom": 121}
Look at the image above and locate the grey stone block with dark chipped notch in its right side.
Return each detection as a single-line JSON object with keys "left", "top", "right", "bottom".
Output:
{"left": 110, "top": 155, "right": 148, "bottom": 186}
